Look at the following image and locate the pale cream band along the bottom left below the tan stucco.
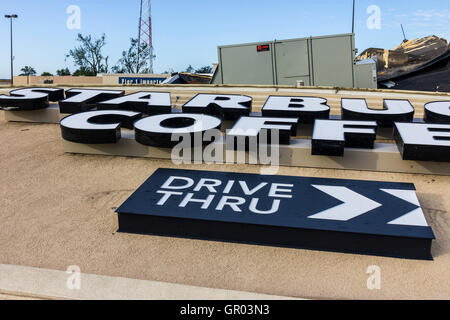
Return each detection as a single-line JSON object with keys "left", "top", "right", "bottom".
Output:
{"left": 0, "top": 264, "right": 302, "bottom": 300}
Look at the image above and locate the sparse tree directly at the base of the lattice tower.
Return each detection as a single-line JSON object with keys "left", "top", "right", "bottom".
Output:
{"left": 112, "top": 38, "right": 155, "bottom": 73}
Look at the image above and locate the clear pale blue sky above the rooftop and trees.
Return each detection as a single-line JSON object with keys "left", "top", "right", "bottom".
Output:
{"left": 0, "top": 0, "right": 450, "bottom": 79}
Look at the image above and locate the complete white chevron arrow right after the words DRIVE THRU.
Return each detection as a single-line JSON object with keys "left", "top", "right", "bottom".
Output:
{"left": 308, "top": 185, "right": 381, "bottom": 221}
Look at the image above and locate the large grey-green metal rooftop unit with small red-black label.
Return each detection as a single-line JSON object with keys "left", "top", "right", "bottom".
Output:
{"left": 212, "top": 34, "right": 356, "bottom": 88}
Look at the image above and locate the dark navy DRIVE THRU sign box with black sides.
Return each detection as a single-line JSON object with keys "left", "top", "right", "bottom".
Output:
{"left": 117, "top": 169, "right": 435, "bottom": 260}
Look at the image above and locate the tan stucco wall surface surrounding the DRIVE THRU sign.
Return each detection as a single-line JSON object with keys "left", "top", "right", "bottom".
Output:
{"left": 0, "top": 112, "right": 450, "bottom": 299}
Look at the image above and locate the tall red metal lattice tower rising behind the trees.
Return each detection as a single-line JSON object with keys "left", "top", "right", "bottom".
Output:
{"left": 137, "top": 0, "right": 153, "bottom": 73}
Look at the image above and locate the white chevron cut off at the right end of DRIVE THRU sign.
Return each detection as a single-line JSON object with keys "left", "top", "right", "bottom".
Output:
{"left": 381, "top": 189, "right": 428, "bottom": 227}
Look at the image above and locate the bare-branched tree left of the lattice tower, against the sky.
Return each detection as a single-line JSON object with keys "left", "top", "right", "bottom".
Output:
{"left": 66, "top": 33, "right": 109, "bottom": 75}
